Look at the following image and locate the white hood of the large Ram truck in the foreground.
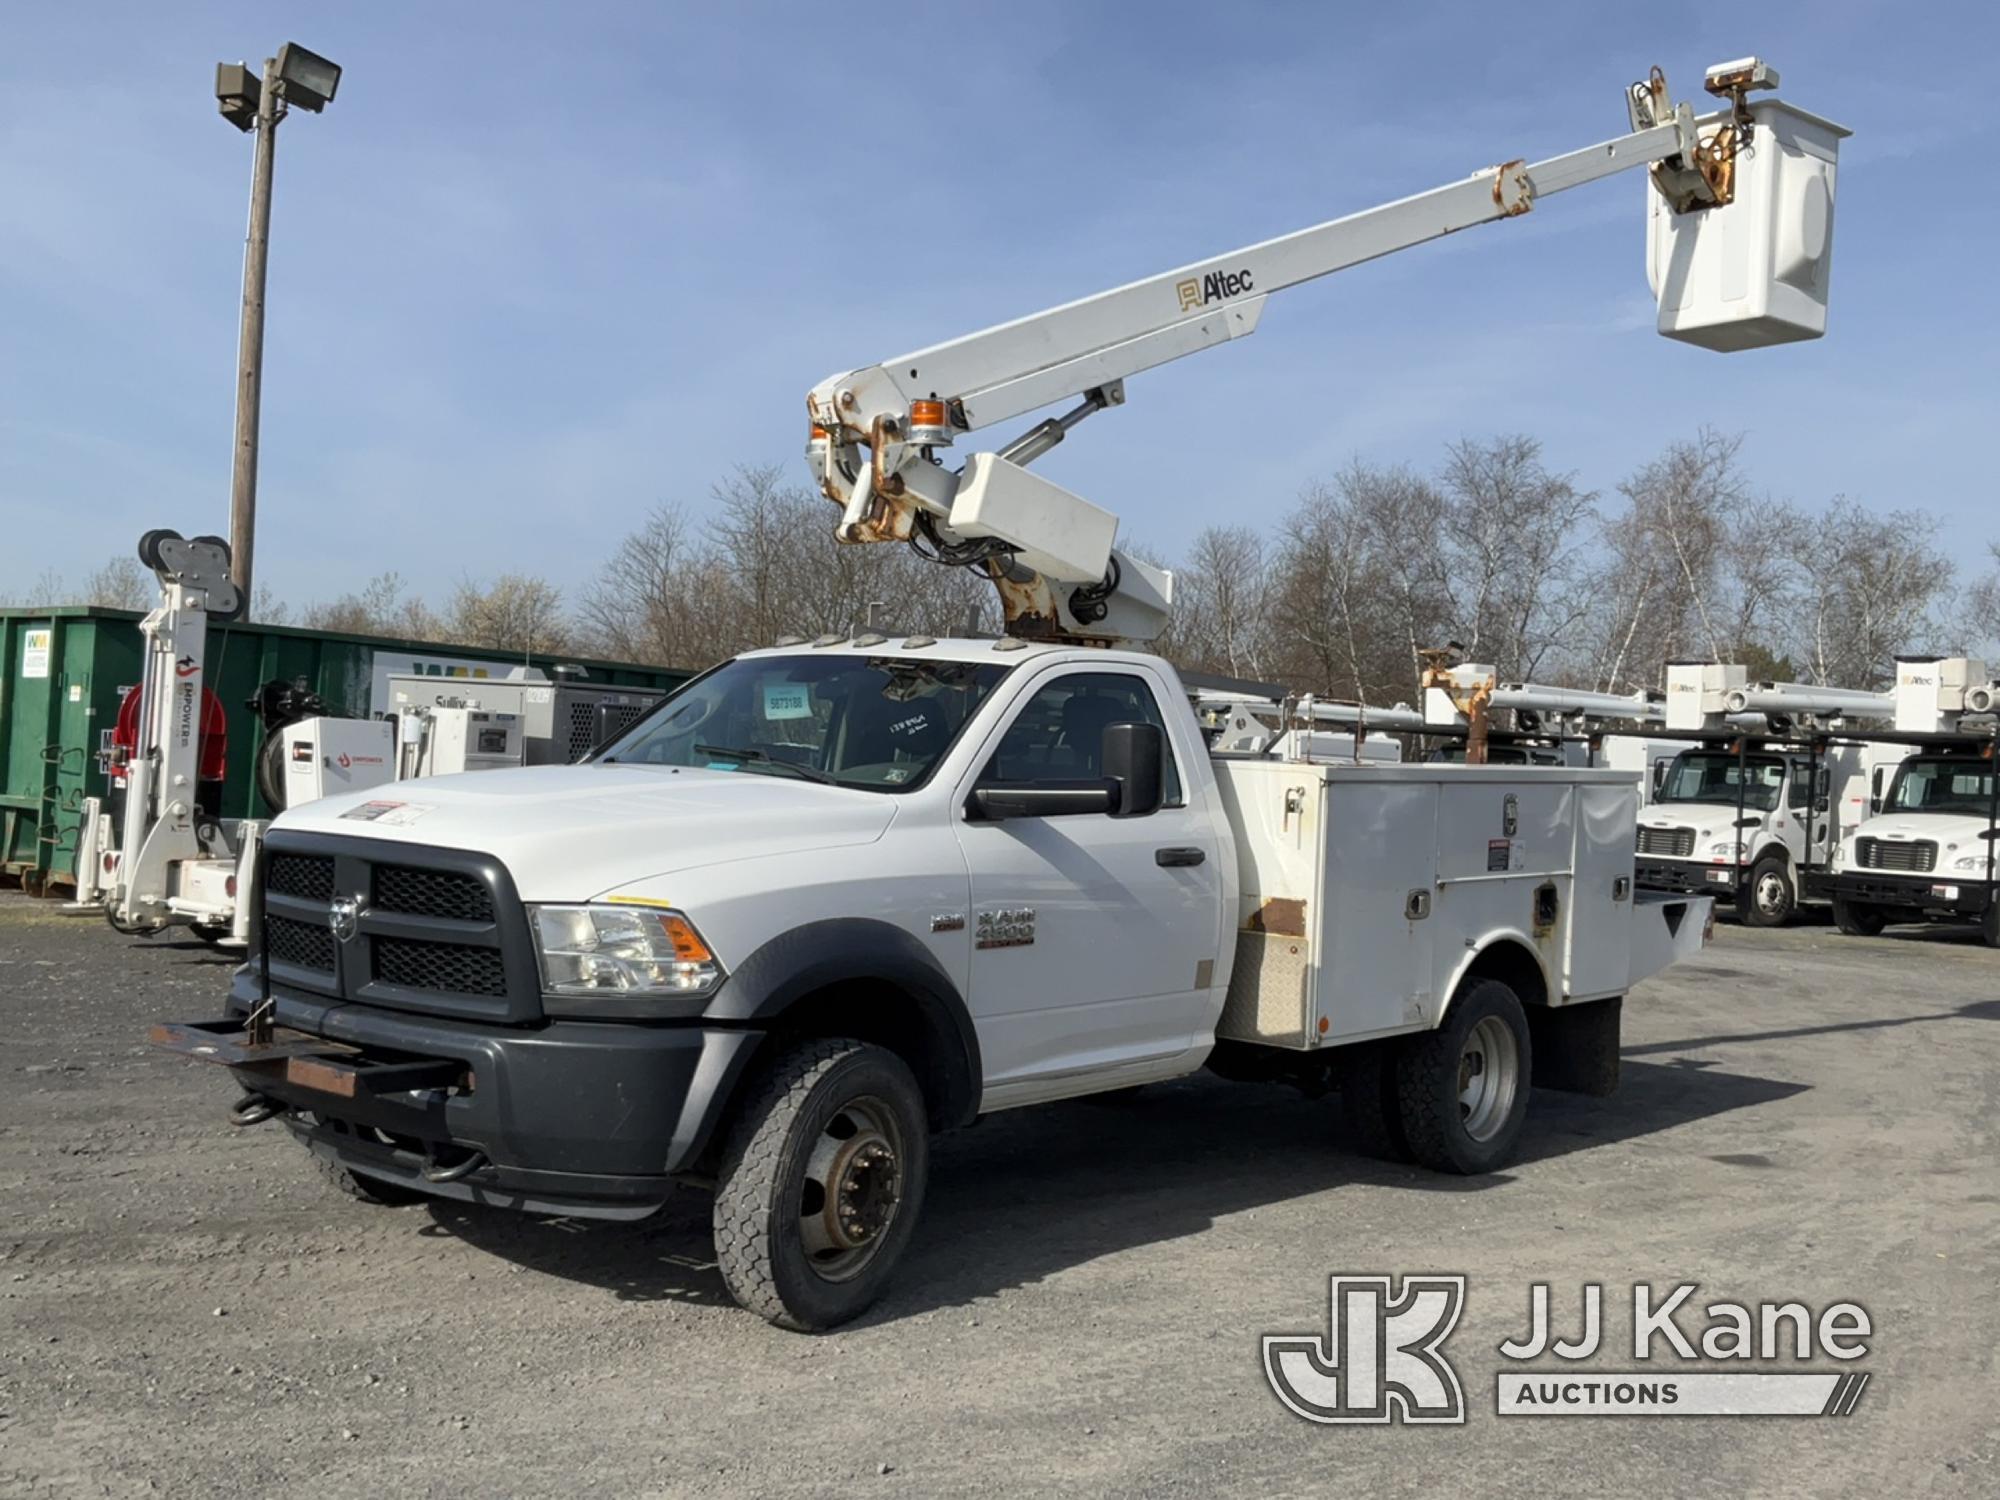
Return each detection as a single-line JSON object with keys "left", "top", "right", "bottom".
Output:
{"left": 272, "top": 766, "right": 896, "bottom": 900}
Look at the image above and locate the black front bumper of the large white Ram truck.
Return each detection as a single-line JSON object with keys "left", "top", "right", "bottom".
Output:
{"left": 168, "top": 970, "right": 762, "bottom": 1218}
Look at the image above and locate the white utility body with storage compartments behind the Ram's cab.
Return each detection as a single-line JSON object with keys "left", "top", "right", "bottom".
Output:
{"left": 1216, "top": 760, "right": 1706, "bottom": 1048}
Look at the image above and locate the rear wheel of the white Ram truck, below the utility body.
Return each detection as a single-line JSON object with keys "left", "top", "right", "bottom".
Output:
{"left": 1396, "top": 980, "right": 1534, "bottom": 1176}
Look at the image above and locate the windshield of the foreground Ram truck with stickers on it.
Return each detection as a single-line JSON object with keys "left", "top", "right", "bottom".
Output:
{"left": 596, "top": 654, "right": 1008, "bottom": 792}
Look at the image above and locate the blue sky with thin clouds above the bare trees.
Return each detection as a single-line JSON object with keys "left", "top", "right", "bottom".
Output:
{"left": 0, "top": 0, "right": 2000, "bottom": 600}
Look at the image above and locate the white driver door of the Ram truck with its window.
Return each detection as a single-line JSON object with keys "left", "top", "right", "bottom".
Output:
{"left": 954, "top": 666, "right": 1222, "bottom": 1108}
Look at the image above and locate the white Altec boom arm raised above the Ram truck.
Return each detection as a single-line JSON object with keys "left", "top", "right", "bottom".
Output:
{"left": 806, "top": 58, "right": 1832, "bottom": 640}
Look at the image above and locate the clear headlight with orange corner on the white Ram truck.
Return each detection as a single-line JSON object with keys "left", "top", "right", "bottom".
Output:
{"left": 528, "top": 902, "right": 722, "bottom": 1016}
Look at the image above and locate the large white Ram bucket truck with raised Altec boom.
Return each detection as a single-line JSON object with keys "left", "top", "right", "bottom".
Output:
{"left": 156, "top": 64, "right": 1838, "bottom": 1328}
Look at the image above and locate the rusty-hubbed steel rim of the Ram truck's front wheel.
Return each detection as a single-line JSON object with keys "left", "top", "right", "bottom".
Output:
{"left": 798, "top": 1094, "right": 906, "bottom": 1282}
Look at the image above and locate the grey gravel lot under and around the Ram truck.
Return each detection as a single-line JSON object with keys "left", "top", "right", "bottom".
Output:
{"left": 0, "top": 896, "right": 2000, "bottom": 1496}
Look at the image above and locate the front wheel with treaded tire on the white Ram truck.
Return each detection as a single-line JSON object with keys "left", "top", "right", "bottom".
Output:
{"left": 714, "top": 1038, "right": 930, "bottom": 1332}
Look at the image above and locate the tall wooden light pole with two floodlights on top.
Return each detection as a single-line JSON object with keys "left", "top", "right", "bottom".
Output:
{"left": 216, "top": 42, "right": 340, "bottom": 618}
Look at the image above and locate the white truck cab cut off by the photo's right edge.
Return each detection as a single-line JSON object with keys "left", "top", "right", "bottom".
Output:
{"left": 1816, "top": 756, "right": 2000, "bottom": 946}
